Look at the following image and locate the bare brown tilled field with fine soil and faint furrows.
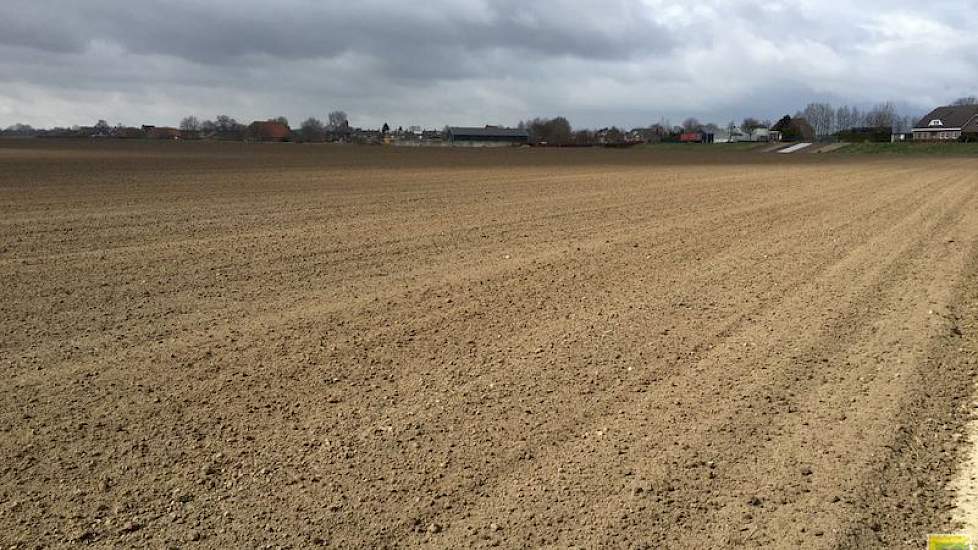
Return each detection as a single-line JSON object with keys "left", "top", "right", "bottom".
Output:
{"left": 0, "top": 141, "right": 978, "bottom": 548}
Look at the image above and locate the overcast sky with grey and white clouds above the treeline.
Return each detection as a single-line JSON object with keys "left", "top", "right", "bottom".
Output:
{"left": 0, "top": 0, "right": 978, "bottom": 128}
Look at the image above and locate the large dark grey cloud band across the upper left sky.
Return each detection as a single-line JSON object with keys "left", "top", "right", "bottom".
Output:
{"left": 0, "top": 0, "right": 670, "bottom": 64}
